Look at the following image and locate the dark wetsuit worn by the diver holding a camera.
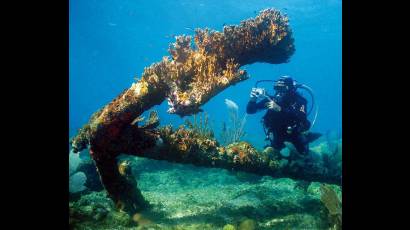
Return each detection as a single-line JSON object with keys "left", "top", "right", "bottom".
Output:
{"left": 246, "top": 92, "right": 311, "bottom": 154}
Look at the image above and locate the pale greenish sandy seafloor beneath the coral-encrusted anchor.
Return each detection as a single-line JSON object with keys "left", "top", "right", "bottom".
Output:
{"left": 70, "top": 139, "right": 342, "bottom": 230}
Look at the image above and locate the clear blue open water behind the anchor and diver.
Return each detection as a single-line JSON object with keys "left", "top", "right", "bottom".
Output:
{"left": 69, "top": 0, "right": 342, "bottom": 147}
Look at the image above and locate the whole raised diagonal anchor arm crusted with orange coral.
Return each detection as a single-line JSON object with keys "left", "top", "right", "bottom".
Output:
{"left": 72, "top": 9, "right": 294, "bottom": 154}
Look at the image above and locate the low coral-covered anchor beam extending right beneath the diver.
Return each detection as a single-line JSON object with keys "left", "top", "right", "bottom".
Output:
{"left": 145, "top": 122, "right": 341, "bottom": 184}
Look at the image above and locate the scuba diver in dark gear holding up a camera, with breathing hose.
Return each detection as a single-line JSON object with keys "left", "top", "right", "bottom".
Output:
{"left": 246, "top": 76, "right": 321, "bottom": 155}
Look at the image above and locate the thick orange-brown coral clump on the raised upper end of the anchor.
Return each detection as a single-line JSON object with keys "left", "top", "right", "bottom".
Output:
{"left": 167, "top": 9, "right": 294, "bottom": 116}
